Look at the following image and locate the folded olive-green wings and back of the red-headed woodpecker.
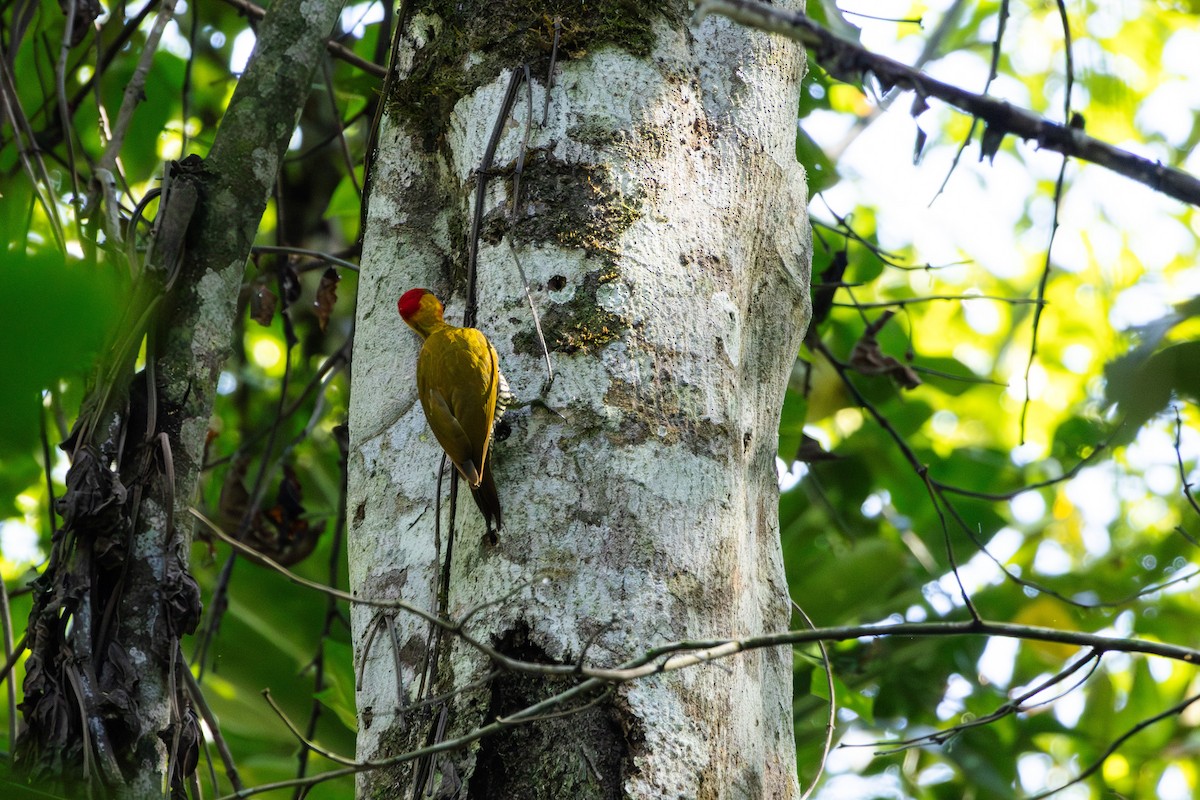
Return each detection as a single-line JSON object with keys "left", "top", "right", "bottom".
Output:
{"left": 416, "top": 327, "right": 499, "bottom": 487}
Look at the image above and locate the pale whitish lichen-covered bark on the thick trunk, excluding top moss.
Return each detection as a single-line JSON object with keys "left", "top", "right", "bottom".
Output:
{"left": 349, "top": 4, "right": 809, "bottom": 798}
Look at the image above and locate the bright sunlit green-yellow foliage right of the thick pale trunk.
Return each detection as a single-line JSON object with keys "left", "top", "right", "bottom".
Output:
{"left": 780, "top": 2, "right": 1200, "bottom": 798}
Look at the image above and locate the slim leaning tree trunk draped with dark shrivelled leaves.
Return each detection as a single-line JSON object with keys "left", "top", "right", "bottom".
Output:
{"left": 18, "top": 0, "right": 342, "bottom": 800}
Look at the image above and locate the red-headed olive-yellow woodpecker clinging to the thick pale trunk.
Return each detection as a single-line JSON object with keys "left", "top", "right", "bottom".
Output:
{"left": 396, "top": 289, "right": 509, "bottom": 541}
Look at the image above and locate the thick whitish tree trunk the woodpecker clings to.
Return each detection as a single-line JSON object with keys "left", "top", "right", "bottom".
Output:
{"left": 349, "top": 1, "right": 810, "bottom": 798}
